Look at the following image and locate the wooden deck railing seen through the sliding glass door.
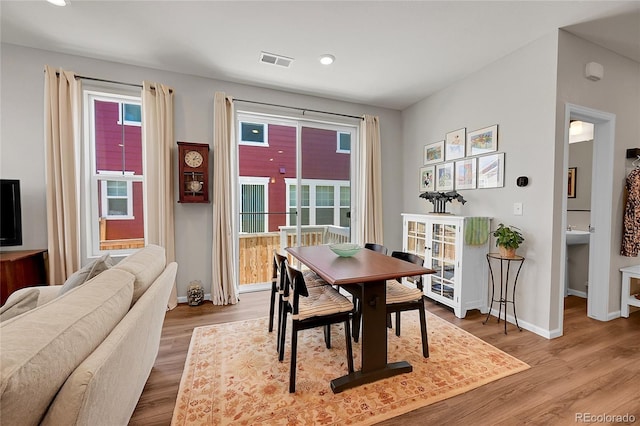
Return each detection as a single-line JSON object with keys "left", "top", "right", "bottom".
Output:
{"left": 239, "top": 225, "right": 350, "bottom": 285}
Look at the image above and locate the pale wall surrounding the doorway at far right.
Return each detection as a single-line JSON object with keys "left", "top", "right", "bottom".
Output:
{"left": 554, "top": 31, "right": 640, "bottom": 316}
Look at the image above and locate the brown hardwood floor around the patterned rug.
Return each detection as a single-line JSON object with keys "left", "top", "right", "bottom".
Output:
{"left": 130, "top": 292, "right": 640, "bottom": 426}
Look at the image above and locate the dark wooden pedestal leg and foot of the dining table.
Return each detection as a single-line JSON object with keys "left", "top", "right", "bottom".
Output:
{"left": 331, "top": 280, "right": 413, "bottom": 393}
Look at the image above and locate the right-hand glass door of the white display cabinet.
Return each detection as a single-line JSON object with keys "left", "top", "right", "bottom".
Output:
{"left": 430, "top": 223, "right": 457, "bottom": 300}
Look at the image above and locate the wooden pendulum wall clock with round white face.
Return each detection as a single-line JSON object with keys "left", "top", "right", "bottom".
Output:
{"left": 178, "top": 142, "right": 209, "bottom": 203}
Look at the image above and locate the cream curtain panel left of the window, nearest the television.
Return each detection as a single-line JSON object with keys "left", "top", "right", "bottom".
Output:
{"left": 44, "top": 66, "right": 82, "bottom": 284}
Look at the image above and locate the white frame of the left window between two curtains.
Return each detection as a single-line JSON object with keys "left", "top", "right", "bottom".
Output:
{"left": 79, "top": 86, "right": 148, "bottom": 263}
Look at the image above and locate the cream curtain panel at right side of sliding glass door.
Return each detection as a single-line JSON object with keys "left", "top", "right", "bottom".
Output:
{"left": 358, "top": 115, "right": 384, "bottom": 244}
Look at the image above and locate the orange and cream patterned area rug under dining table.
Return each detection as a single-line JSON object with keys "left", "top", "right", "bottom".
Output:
{"left": 171, "top": 311, "right": 529, "bottom": 426}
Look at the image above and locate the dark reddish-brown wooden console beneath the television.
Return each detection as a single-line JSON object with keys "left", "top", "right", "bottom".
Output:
{"left": 0, "top": 250, "right": 47, "bottom": 305}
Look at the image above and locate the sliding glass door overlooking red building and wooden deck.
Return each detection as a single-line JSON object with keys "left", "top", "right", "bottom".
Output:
{"left": 237, "top": 113, "right": 357, "bottom": 291}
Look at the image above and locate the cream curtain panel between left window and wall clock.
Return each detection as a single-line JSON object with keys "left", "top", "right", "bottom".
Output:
{"left": 142, "top": 81, "right": 178, "bottom": 309}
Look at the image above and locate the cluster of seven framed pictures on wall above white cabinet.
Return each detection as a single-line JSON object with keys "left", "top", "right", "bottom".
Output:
{"left": 420, "top": 124, "right": 504, "bottom": 192}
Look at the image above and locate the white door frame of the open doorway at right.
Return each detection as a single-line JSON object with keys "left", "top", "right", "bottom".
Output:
{"left": 558, "top": 104, "right": 615, "bottom": 329}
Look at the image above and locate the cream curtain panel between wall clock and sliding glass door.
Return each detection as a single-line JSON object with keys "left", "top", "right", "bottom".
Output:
{"left": 211, "top": 92, "right": 239, "bottom": 305}
